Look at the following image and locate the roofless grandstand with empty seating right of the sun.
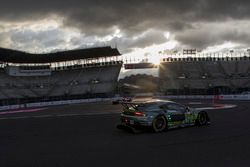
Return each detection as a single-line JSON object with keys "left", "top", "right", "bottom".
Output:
{"left": 159, "top": 54, "right": 250, "bottom": 95}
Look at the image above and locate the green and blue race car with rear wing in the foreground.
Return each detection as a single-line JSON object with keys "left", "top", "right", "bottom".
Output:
{"left": 117, "top": 100, "right": 210, "bottom": 132}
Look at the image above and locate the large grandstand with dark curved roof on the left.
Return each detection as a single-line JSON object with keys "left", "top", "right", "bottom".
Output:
{"left": 0, "top": 47, "right": 123, "bottom": 105}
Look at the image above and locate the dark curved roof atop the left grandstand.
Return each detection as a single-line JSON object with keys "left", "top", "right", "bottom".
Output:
{"left": 0, "top": 47, "right": 121, "bottom": 64}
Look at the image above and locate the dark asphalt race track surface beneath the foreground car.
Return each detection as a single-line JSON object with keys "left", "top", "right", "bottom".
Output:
{"left": 0, "top": 101, "right": 250, "bottom": 167}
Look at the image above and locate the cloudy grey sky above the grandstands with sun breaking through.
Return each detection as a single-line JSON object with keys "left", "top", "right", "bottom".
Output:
{"left": 0, "top": 0, "right": 250, "bottom": 54}
